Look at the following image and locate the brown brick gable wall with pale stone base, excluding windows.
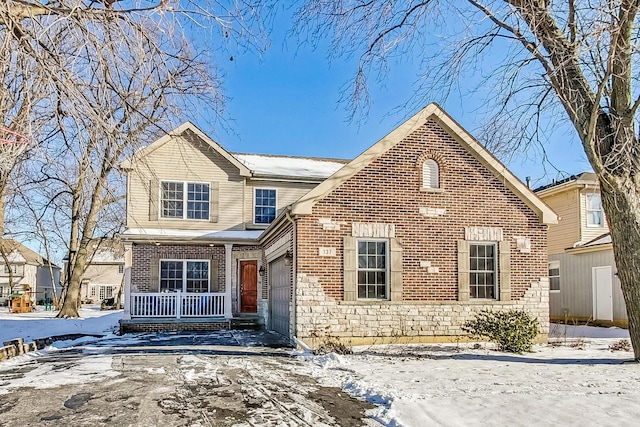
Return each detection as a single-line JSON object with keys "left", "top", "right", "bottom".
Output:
{"left": 295, "top": 121, "right": 548, "bottom": 342}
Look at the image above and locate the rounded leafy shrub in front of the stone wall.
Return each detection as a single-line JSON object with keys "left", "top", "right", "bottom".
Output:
{"left": 462, "top": 310, "right": 540, "bottom": 353}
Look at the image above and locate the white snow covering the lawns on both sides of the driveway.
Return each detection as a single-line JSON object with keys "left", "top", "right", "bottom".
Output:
{"left": 0, "top": 310, "right": 640, "bottom": 426}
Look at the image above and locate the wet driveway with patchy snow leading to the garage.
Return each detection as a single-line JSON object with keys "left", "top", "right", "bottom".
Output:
{"left": 0, "top": 331, "right": 377, "bottom": 427}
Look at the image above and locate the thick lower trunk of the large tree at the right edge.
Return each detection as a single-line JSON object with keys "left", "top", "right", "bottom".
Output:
{"left": 600, "top": 176, "right": 640, "bottom": 361}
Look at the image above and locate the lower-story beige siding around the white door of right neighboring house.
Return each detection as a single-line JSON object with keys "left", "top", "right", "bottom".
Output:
{"left": 549, "top": 249, "right": 627, "bottom": 321}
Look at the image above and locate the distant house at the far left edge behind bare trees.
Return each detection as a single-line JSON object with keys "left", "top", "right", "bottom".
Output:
{"left": 0, "top": 239, "right": 62, "bottom": 305}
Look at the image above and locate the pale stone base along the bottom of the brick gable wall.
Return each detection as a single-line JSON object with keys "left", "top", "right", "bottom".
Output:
{"left": 296, "top": 274, "right": 549, "bottom": 347}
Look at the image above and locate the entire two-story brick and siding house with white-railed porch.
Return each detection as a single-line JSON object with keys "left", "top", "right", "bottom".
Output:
{"left": 122, "top": 104, "right": 557, "bottom": 344}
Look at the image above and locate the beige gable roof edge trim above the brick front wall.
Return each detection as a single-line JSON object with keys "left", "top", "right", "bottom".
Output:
{"left": 291, "top": 103, "right": 558, "bottom": 224}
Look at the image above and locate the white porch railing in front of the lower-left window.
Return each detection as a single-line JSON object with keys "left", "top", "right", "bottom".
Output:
{"left": 129, "top": 291, "right": 226, "bottom": 319}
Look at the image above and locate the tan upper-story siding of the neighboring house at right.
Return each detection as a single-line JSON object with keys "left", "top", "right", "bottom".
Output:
{"left": 541, "top": 187, "right": 580, "bottom": 254}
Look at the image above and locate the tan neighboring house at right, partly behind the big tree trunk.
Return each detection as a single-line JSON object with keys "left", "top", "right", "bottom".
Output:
{"left": 535, "top": 172, "right": 628, "bottom": 326}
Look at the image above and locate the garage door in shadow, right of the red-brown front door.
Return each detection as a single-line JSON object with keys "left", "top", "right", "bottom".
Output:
{"left": 269, "top": 256, "right": 291, "bottom": 337}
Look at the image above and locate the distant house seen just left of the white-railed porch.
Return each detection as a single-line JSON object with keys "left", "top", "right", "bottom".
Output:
{"left": 73, "top": 240, "right": 124, "bottom": 303}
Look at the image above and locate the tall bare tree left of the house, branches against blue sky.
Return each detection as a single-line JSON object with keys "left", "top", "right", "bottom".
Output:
{"left": 0, "top": 0, "right": 270, "bottom": 317}
